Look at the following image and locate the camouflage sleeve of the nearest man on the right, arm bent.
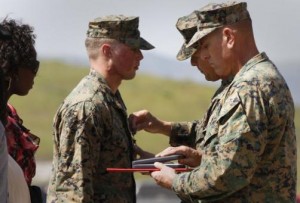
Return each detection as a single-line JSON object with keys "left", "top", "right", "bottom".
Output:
{"left": 172, "top": 90, "right": 267, "bottom": 201}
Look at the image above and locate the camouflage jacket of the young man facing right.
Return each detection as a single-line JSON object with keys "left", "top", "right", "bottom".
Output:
{"left": 47, "top": 69, "right": 135, "bottom": 203}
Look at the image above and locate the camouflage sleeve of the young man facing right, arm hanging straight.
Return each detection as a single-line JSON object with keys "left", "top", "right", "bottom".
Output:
{"left": 56, "top": 102, "right": 103, "bottom": 203}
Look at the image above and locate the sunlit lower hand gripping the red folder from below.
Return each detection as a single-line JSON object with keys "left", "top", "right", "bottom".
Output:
{"left": 150, "top": 162, "right": 176, "bottom": 189}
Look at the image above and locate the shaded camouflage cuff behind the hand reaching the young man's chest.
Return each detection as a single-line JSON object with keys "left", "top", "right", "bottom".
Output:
{"left": 169, "top": 122, "right": 196, "bottom": 147}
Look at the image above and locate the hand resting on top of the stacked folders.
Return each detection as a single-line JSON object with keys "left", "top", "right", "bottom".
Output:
{"left": 156, "top": 145, "right": 201, "bottom": 167}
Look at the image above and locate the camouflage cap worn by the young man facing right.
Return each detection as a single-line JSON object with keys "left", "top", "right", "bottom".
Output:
{"left": 87, "top": 15, "right": 154, "bottom": 50}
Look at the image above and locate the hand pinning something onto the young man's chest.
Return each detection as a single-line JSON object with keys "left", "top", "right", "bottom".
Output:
{"left": 128, "top": 110, "right": 171, "bottom": 135}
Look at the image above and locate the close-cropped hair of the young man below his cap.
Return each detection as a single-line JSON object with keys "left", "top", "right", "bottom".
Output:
{"left": 85, "top": 37, "right": 119, "bottom": 59}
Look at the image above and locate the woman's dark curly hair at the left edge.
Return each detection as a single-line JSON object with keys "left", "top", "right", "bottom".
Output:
{"left": 0, "top": 19, "right": 37, "bottom": 75}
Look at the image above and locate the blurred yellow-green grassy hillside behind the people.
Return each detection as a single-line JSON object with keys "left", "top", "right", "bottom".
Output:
{"left": 10, "top": 61, "right": 300, "bottom": 191}
